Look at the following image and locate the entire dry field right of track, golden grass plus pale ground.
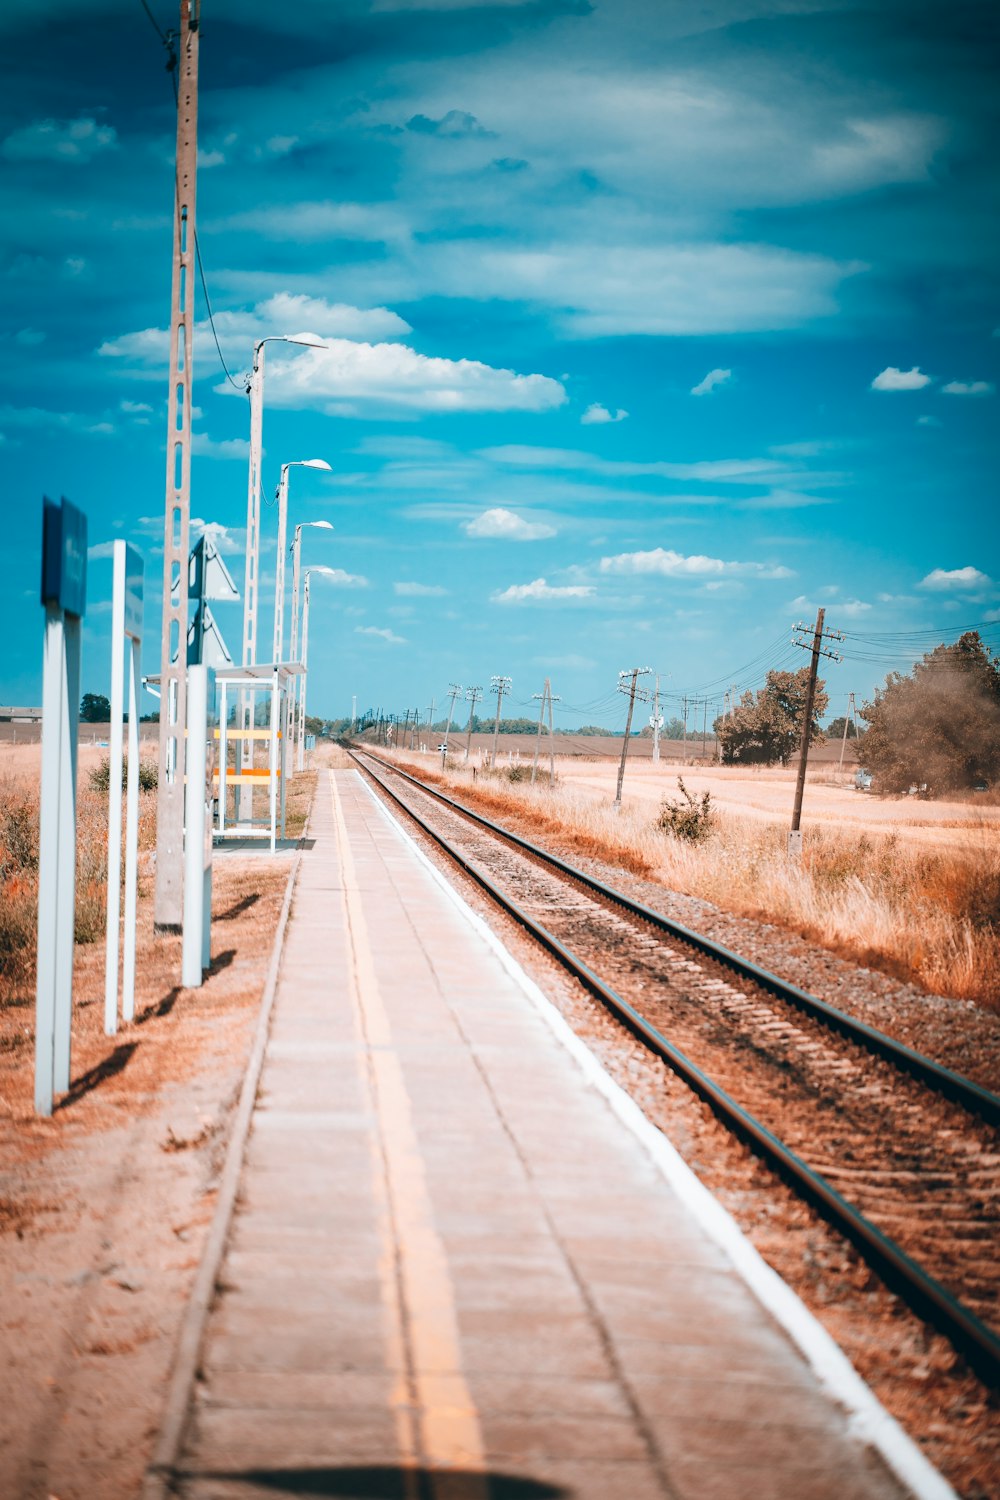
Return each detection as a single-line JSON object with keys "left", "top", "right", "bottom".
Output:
{"left": 383, "top": 741, "right": 1000, "bottom": 1008}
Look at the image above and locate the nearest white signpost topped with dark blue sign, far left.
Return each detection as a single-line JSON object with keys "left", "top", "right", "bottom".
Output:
{"left": 34, "top": 500, "right": 87, "bottom": 1115}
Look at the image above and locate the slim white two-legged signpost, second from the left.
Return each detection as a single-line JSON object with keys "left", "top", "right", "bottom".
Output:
{"left": 103, "top": 540, "right": 142, "bottom": 1037}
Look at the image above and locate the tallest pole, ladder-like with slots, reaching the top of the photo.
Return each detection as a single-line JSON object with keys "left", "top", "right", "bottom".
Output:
{"left": 153, "top": 0, "right": 201, "bottom": 929}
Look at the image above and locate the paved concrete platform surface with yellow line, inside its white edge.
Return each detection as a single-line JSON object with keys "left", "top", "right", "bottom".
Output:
{"left": 178, "top": 771, "right": 948, "bottom": 1500}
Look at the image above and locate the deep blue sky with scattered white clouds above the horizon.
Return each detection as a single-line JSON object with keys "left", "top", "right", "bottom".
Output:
{"left": 0, "top": 0, "right": 1000, "bottom": 728}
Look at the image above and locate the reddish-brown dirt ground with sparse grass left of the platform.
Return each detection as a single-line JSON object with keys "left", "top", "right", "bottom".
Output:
{"left": 0, "top": 762, "right": 315, "bottom": 1500}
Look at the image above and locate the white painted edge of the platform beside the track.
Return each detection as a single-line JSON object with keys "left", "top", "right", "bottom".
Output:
{"left": 354, "top": 771, "right": 958, "bottom": 1500}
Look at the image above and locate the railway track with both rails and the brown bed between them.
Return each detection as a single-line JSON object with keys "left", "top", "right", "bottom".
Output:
{"left": 350, "top": 756, "right": 1000, "bottom": 1388}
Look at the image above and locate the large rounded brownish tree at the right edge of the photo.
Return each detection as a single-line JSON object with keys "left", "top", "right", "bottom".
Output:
{"left": 861, "top": 630, "right": 1000, "bottom": 797}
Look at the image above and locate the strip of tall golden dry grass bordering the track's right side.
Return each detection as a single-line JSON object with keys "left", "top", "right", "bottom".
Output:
{"left": 386, "top": 750, "right": 1000, "bottom": 1008}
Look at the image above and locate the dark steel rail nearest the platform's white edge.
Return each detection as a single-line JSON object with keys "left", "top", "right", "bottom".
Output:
{"left": 358, "top": 756, "right": 1000, "bottom": 1389}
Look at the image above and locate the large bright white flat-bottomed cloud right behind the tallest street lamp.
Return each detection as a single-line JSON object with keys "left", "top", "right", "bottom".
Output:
{"left": 267, "top": 335, "right": 567, "bottom": 411}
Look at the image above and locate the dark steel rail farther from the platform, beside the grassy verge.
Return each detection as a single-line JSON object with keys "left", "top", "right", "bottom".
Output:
{"left": 351, "top": 752, "right": 1000, "bottom": 1125}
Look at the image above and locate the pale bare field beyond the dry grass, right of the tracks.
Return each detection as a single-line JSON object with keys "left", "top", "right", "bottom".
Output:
{"left": 556, "top": 758, "right": 1000, "bottom": 851}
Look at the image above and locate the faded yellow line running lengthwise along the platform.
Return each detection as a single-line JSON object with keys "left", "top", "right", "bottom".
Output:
{"left": 330, "top": 773, "right": 487, "bottom": 1500}
